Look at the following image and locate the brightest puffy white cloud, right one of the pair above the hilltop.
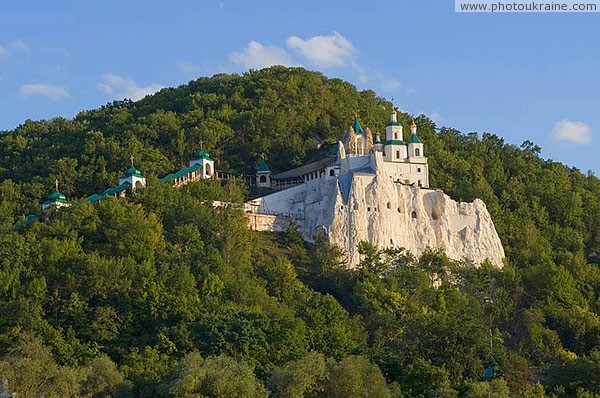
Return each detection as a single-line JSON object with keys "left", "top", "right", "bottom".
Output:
{"left": 286, "top": 32, "right": 355, "bottom": 68}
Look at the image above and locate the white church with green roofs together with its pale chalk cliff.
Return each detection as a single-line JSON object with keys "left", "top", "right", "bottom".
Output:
{"left": 245, "top": 110, "right": 504, "bottom": 267}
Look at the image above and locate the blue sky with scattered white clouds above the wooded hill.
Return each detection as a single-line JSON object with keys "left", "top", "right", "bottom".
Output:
{"left": 0, "top": 0, "right": 600, "bottom": 175}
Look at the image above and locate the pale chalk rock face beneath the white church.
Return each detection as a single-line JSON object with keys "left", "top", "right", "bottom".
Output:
{"left": 253, "top": 152, "right": 504, "bottom": 267}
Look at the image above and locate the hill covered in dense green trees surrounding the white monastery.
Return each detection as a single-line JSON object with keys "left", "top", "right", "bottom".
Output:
{"left": 0, "top": 67, "right": 600, "bottom": 397}
